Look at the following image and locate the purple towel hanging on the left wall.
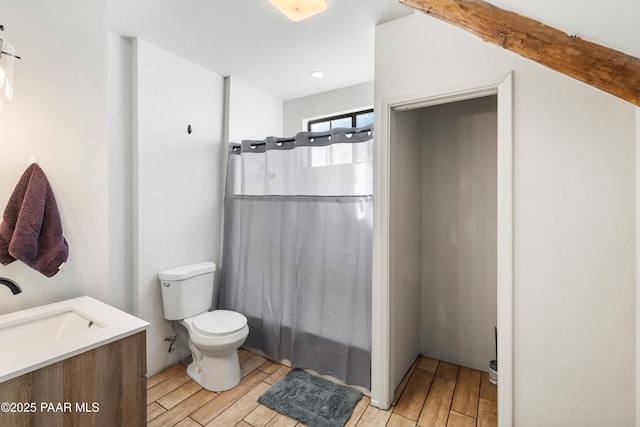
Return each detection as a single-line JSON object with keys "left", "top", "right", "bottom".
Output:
{"left": 0, "top": 163, "right": 69, "bottom": 277}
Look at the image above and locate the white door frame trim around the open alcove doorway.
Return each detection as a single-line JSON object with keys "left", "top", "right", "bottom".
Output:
{"left": 371, "top": 73, "right": 513, "bottom": 426}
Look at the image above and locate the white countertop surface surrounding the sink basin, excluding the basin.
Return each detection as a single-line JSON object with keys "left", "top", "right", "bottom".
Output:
{"left": 0, "top": 296, "right": 149, "bottom": 382}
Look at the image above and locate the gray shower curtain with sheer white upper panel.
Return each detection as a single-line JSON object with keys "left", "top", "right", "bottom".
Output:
{"left": 219, "top": 128, "right": 373, "bottom": 388}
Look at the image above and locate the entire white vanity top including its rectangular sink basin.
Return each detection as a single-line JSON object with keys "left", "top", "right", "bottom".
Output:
{"left": 0, "top": 296, "right": 149, "bottom": 382}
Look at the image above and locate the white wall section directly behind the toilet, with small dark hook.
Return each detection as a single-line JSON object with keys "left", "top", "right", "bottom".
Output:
{"left": 133, "top": 39, "right": 224, "bottom": 374}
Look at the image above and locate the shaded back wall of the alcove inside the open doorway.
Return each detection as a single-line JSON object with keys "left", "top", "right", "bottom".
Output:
{"left": 418, "top": 97, "right": 498, "bottom": 372}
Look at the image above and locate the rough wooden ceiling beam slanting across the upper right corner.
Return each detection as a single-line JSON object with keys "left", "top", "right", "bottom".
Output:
{"left": 399, "top": 0, "right": 640, "bottom": 106}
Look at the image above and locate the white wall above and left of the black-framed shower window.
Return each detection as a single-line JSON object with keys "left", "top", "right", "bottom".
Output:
{"left": 283, "top": 82, "right": 373, "bottom": 136}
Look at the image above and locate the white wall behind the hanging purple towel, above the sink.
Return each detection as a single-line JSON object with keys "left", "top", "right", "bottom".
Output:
{"left": 0, "top": 0, "right": 111, "bottom": 313}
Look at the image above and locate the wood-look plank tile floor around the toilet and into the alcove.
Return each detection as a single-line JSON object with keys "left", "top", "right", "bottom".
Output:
{"left": 147, "top": 349, "right": 498, "bottom": 427}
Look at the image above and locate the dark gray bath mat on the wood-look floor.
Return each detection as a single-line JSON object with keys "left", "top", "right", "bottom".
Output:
{"left": 258, "top": 369, "right": 362, "bottom": 427}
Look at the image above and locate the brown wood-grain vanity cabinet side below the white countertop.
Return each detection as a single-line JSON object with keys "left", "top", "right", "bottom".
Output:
{"left": 0, "top": 331, "right": 147, "bottom": 427}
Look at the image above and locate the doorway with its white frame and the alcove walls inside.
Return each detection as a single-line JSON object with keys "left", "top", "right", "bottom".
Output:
{"left": 371, "top": 74, "right": 513, "bottom": 425}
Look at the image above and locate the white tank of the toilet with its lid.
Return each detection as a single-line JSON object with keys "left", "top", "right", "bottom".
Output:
{"left": 158, "top": 262, "right": 216, "bottom": 320}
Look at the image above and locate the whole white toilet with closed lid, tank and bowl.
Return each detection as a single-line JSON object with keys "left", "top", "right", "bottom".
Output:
{"left": 158, "top": 262, "right": 249, "bottom": 391}
